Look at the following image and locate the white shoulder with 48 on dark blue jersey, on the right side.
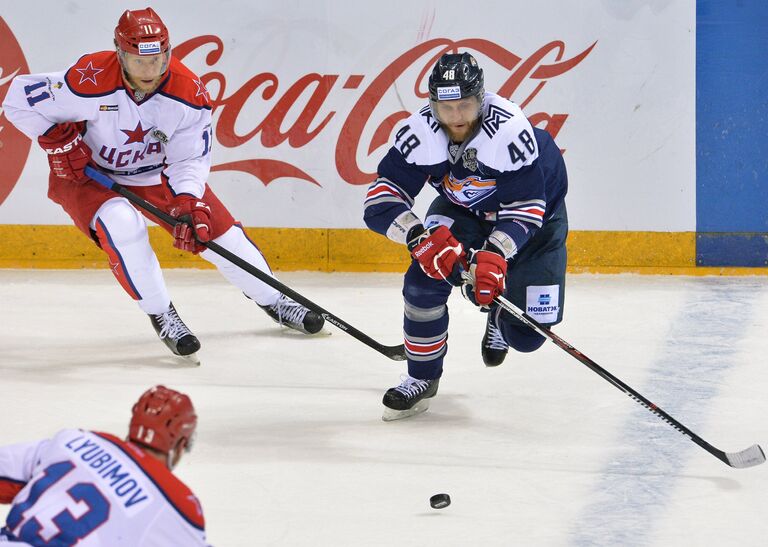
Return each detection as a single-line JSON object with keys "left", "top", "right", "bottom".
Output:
{"left": 477, "top": 93, "right": 539, "bottom": 172}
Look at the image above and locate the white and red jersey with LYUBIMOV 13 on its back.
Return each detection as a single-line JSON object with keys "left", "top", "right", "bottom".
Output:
{"left": 0, "top": 429, "right": 208, "bottom": 547}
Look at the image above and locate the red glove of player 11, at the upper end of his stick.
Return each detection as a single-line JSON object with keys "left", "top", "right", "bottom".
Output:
{"left": 37, "top": 122, "right": 91, "bottom": 183}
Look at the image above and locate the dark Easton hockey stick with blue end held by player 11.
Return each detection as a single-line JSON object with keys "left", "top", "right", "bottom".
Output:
{"left": 85, "top": 165, "right": 405, "bottom": 361}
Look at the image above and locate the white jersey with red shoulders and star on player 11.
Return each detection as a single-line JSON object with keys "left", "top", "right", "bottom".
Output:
{"left": 3, "top": 51, "right": 212, "bottom": 197}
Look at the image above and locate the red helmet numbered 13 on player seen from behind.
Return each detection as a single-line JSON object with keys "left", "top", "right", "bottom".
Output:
{"left": 128, "top": 386, "right": 197, "bottom": 454}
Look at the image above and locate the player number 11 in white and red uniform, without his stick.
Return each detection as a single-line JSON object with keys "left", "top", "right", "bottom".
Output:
{"left": 3, "top": 8, "right": 324, "bottom": 364}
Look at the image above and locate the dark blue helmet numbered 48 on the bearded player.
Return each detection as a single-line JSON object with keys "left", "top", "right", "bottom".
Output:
{"left": 429, "top": 51, "right": 485, "bottom": 102}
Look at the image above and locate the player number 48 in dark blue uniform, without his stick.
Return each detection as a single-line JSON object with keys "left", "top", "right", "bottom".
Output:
{"left": 365, "top": 53, "right": 568, "bottom": 421}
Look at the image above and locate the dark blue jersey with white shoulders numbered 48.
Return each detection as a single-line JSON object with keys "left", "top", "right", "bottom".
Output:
{"left": 364, "top": 93, "right": 568, "bottom": 258}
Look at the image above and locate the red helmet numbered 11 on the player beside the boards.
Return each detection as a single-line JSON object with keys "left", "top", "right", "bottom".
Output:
{"left": 115, "top": 8, "right": 171, "bottom": 55}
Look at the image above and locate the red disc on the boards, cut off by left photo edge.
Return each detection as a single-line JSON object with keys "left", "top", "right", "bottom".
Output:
{"left": 0, "top": 17, "right": 30, "bottom": 208}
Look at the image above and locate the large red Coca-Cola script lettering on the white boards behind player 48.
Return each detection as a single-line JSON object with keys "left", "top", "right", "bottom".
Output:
{"left": 173, "top": 35, "right": 597, "bottom": 185}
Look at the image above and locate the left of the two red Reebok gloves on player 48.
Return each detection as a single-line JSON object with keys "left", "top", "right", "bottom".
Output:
{"left": 408, "top": 225, "right": 467, "bottom": 286}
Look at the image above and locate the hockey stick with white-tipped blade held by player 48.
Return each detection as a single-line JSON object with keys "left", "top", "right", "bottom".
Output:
{"left": 488, "top": 296, "right": 765, "bottom": 468}
